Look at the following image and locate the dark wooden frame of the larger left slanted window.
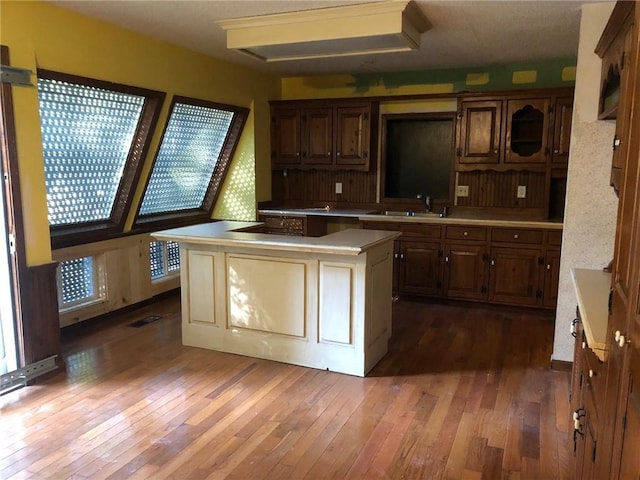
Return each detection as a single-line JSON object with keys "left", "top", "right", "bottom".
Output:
{"left": 37, "top": 68, "right": 166, "bottom": 249}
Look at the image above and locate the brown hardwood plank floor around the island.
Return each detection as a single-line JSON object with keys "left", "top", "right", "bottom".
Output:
{"left": 0, "top": 297, "right": 573, "bottom": 480}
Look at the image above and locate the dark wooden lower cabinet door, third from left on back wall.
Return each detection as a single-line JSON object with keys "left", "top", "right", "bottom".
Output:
{"left": 489, "top": 248, "right": 542, "bottom": 305}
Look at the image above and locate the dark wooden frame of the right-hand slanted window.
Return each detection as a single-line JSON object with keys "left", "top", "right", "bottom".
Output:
{"left": 134, "top": 95, "right": 250, "bottom": 231}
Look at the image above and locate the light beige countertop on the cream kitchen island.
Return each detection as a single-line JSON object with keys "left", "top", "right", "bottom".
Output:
{"left": 151, "top": 221, "right": 400, "bottom": 255}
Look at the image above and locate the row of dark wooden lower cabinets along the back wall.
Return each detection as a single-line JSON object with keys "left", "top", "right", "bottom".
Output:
{"left": 362, "top": 221, "right": 561, "bottom": 308}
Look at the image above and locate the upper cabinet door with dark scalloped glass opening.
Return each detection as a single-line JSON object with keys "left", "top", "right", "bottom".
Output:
{"left": 504, "top": 98, "right": 551, "bottom": 163}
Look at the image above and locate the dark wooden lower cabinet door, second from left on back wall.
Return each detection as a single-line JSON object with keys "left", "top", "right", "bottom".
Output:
{"left": 443, "top": 244, "right": 486, "bottom": 300}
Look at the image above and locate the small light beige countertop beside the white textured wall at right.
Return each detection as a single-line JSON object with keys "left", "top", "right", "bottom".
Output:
{"left": 571, "top": 268, "right": 611, "bottom": 361}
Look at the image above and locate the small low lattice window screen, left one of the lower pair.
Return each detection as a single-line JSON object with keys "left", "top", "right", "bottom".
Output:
{"left": 58, "top": 257, "right": 98, "bottom": 307}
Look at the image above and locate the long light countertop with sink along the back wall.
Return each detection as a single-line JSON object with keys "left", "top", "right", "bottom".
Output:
{"left": 258, "top": 207, "right": 562, "bottom": 230}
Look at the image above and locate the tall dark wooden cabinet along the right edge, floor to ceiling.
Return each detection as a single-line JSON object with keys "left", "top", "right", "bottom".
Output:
{"left": 576, "top": 2, "right": 640, "bottom": 480}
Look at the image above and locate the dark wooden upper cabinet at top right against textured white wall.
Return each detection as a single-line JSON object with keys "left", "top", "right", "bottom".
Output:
{"left": 596, "top": 2, "right": 637, "bottom": 193}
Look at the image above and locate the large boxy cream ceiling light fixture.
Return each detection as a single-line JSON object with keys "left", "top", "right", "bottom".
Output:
{"left": 216, "top": 0, "right": 431, "bottom": 62}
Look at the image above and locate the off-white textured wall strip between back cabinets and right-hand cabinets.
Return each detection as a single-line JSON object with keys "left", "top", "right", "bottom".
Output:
{"left": 551, "top": 2, "right": 618, "bottom": 361}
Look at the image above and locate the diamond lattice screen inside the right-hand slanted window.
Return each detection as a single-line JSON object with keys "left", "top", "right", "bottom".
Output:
{"left": 140, "top": 103, "right": 234, "bottom": 215}
